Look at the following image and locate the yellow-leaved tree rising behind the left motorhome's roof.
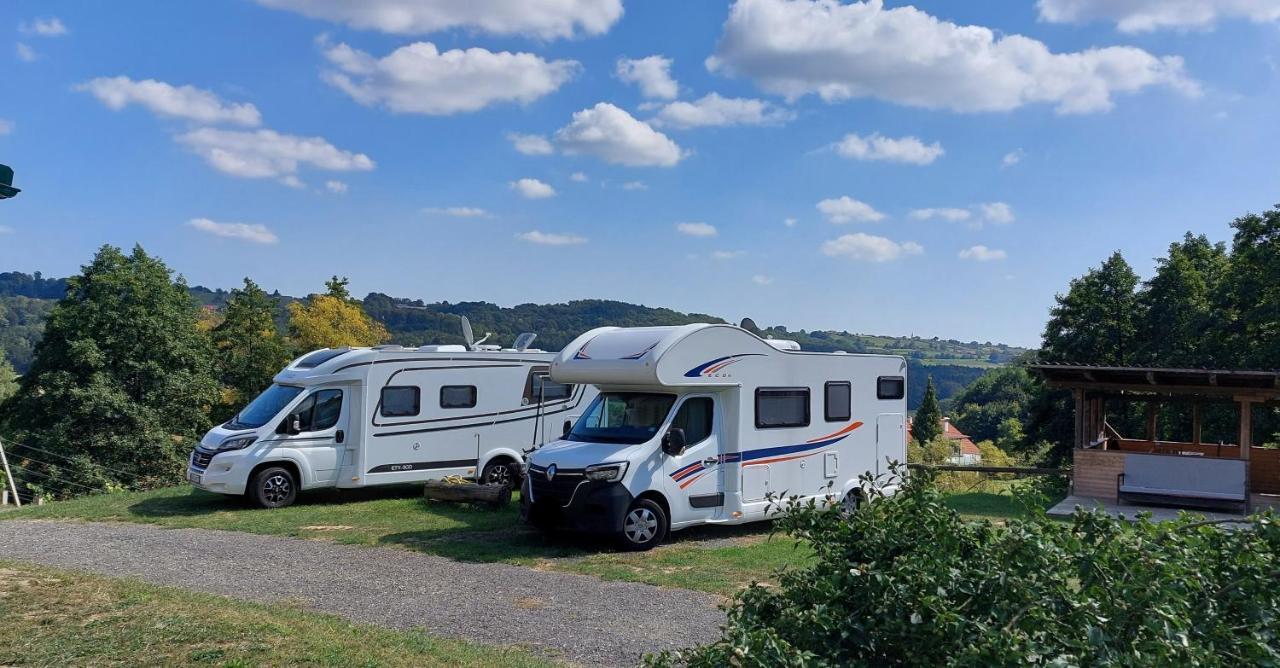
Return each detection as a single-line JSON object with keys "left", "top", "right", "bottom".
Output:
{"left": 289, "top": 276, "right": 389, "bottom": 351}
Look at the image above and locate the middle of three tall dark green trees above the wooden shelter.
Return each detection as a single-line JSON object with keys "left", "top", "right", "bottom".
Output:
{"left": 1138, "top": 233, "right": 1228, "bottom": 367}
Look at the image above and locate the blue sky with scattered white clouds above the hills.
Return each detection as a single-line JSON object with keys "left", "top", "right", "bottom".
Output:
{"left": 0, "top": 0, "right": 1280, "bottom": 344}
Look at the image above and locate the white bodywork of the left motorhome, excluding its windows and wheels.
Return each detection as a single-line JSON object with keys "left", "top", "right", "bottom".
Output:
{"left": 188, "top": 346, "right": 595, "bottom": 494}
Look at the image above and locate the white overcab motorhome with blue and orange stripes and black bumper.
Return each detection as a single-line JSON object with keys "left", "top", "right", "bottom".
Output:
{"left": 521, "top": 324, "right": 906, "bottom": 549}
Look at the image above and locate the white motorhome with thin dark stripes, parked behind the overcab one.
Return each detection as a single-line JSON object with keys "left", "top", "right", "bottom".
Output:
{"left": 187, "top": 328, "right": 595, "bottom": 508}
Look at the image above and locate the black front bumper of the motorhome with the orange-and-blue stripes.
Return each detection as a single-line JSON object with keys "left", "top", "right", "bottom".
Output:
{"left": 520, "top": 471, "right": 635, "bottom": 534}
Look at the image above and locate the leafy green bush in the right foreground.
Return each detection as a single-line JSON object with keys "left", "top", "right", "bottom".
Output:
{"left": 649, "top": 473, "right": 1280, "bottom": 667}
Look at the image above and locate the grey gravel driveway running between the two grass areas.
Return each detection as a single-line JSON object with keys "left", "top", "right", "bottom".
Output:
{"left": 0, "top": 520, "right": 724, "bottom": 665}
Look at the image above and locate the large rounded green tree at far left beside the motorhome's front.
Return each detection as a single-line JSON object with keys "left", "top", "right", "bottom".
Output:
{"left": 0, "top": 246, "right": 218, "bottom": 494}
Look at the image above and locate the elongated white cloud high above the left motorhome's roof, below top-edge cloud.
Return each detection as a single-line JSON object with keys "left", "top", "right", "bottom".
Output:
{"left": 324, "top": 42, "right": 581, "bottom": 115}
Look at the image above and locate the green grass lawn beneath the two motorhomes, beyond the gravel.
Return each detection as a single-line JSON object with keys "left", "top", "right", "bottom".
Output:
{"left": 4, "top": 486, "right": 1024, "bottom": 595}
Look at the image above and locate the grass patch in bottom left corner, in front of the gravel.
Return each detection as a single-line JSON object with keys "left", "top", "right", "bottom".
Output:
{"left": 0, "top": 561, "right": 553, "bottom": 668}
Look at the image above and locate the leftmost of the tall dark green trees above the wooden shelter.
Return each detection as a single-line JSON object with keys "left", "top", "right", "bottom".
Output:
{"left": 1041, "top": 251, "right": 1139, "bottom": 366}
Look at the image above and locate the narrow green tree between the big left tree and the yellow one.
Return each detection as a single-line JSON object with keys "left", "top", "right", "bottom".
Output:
{"left": 211, "top": 278, "right": 291, "bottom": 406}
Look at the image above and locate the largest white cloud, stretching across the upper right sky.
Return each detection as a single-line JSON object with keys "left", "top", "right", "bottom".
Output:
{"left": 707, "top": 0, "right": 1199, "bottom": 114}
